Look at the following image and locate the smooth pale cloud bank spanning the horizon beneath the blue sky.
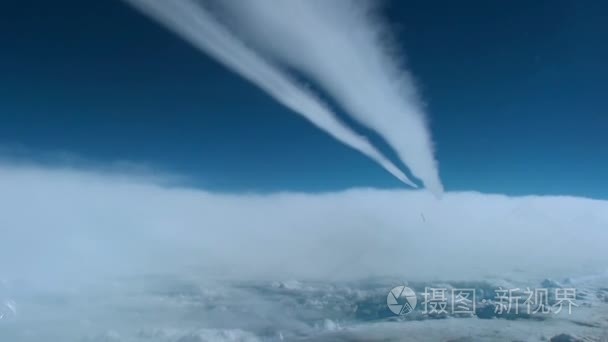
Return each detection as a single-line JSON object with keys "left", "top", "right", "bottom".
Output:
{"left": 0, "top": 164, "right": 608, "bottom": 288}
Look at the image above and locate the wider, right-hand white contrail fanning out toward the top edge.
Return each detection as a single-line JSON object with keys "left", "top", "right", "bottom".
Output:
{"left": 211, "top": 0, "right": 443, "bottom": 195}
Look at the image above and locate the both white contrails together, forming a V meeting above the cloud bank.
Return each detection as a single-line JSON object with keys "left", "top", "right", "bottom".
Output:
{"left": 127, "top": 0, "right": 443, "bottom": 195}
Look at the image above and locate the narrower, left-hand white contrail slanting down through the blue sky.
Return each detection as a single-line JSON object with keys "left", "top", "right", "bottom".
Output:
{"left": 125, "top": 0, "right": 417, "bottom": 187}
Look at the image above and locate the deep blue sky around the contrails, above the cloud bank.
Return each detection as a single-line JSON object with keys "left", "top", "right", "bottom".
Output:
{"left": 0, "top": 1, "right": 608, "bottom": 198}
